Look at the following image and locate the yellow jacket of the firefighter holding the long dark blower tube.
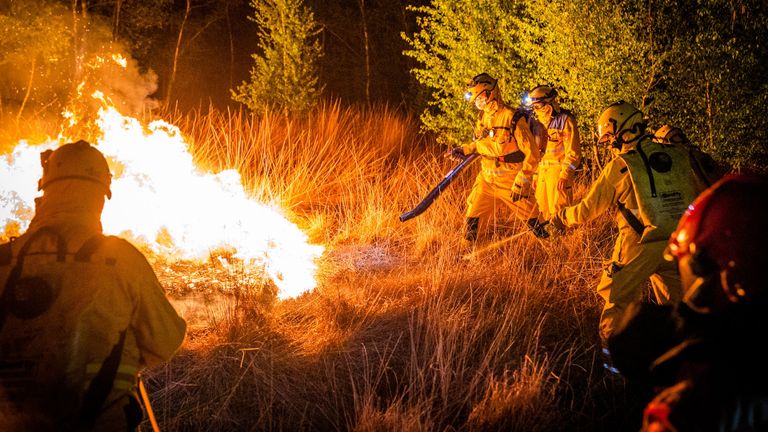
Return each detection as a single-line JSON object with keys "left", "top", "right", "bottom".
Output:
{"left": 462, "top": 102, "right": 541, "bottom": 183}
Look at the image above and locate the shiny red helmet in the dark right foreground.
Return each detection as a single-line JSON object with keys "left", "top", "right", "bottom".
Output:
{"left": 665, "top": 175, "right": 768, "bottom": 313}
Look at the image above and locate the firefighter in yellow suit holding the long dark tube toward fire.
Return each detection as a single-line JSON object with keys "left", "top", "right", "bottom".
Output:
{"left": 446, "top": 73, "right": 549, "bottom": 243}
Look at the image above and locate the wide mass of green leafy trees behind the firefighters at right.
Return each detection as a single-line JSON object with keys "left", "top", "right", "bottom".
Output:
{"left": 403, "top": 0, "right": 768, "bottom": 171}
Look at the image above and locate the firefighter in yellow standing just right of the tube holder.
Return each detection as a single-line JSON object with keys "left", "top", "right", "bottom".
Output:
{"left": 526, "top": 85, "right": 581, "bottom": 219}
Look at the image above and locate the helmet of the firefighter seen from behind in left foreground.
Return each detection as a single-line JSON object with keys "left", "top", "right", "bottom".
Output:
{"left": 37, "top": 140, "right": 112, "bottom": 198}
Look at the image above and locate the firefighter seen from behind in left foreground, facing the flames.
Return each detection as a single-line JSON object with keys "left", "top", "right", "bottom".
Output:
{"left": 0, "top": 141, "right": 186, "bottom": 431}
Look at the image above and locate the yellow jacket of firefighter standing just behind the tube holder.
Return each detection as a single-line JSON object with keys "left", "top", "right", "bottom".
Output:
{"left": 541, "top": 109, "right": 581, "bottom": 180}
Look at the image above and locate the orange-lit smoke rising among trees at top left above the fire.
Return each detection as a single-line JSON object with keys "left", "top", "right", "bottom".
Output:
{"left": 0, "top": 0, "right": 159, "bottom": 123}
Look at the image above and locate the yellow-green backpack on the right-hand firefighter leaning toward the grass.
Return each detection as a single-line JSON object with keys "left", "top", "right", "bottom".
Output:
{"left": 619, "top": 139, "right": 699, "bottom": 243}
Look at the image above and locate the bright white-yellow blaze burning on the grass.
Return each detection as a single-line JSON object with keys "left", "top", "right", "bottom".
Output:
{"left": 0, "top": 107, "right": 323, "bottom": 299}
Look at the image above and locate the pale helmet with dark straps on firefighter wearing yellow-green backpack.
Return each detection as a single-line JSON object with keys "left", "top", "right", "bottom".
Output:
{"left": 597, "top": 100, "right": 647, "bottom": 149}
